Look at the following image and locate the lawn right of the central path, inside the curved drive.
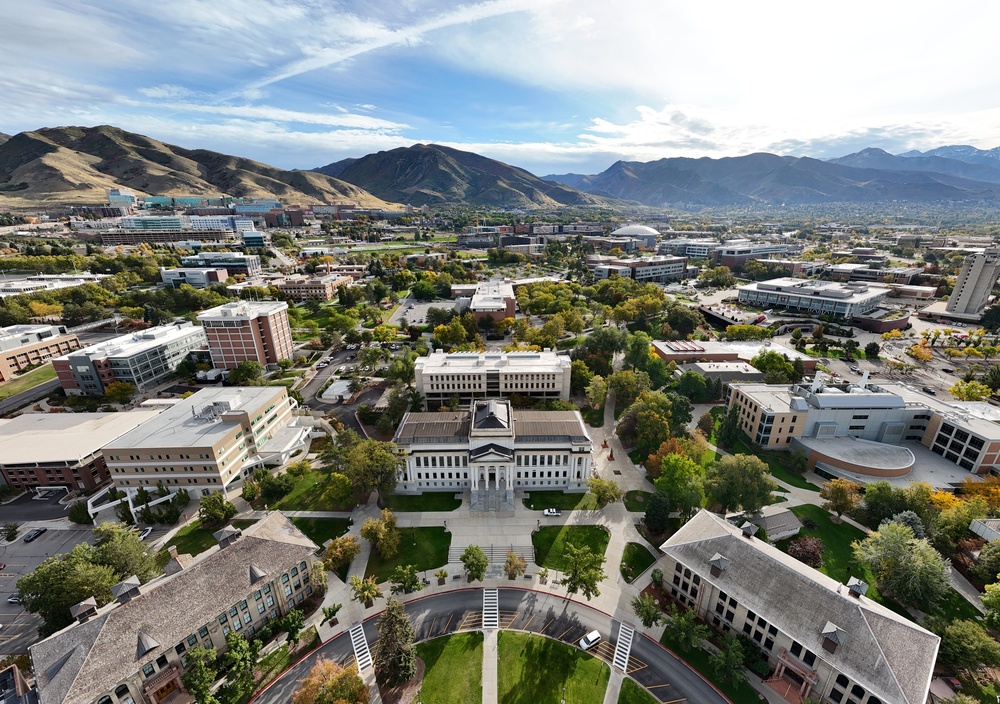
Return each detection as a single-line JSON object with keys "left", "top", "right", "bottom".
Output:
{"left": 498, "top": 631, "right": 611, "bottom": 704}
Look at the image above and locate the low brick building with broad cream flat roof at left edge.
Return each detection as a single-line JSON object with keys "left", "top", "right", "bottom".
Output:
{"left": 0, "top": 410, "right": 159, "bottom": 492}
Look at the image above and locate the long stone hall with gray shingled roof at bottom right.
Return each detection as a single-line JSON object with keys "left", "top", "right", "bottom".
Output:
{"left": 660, "top": 510, "right": 941, "bottom": 704}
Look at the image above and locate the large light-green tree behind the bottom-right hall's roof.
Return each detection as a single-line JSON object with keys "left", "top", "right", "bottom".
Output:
{"left": 851, "top": 523, "right": 949, "bottom": 607}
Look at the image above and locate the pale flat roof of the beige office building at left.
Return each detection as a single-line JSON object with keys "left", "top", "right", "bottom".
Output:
{"left": 108, "top": 386, "right": 284, "bottom": 449}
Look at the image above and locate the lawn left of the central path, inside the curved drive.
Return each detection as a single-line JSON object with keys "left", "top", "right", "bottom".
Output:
{"left": 417, "top": 633, "right": 483, "bottom": 704}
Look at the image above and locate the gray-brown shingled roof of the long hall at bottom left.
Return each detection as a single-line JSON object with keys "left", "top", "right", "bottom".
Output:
{"left": 30, "top": 512, "right": 318, "bottom": 704}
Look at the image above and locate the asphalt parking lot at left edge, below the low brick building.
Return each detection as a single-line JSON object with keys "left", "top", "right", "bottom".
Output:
{"left": 0, "top": 528, "right": 94, "bottom": 657}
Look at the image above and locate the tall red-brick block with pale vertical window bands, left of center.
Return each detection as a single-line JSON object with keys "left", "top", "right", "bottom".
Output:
{"left": 198, "top": 301, "right": 293, "bottom": 369}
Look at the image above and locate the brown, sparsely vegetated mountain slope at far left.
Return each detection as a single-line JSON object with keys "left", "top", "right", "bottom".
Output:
{"left": 0, "top": 125, "right": 391, "bottom": 207}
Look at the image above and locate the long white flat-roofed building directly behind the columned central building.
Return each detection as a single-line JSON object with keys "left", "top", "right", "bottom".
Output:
{"left": 414, "top": 351, "right": 572, "bottom": 409}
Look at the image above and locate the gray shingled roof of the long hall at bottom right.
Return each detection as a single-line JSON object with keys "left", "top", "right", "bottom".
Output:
{"left": 662, "top": 511, "right": 940, "bottom": 704}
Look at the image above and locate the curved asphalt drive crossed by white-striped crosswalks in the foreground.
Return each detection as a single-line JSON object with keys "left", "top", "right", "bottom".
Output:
{"left": 253, "top": 588, "right": 728, "bottom": 704}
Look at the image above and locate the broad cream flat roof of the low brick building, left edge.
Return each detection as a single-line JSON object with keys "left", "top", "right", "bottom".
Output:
{"left": 0, "top": 409, "right": 161, "bottom": 465}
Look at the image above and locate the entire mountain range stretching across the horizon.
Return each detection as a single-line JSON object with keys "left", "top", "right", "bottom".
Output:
{"left": 0, "top": 125, "right": 1000, "bottom": 209}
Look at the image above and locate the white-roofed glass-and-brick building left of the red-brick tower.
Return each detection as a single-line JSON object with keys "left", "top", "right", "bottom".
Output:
{"left": 52, "top": 321, "right": 206, "bottom": 396}
